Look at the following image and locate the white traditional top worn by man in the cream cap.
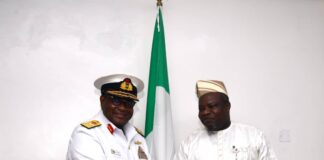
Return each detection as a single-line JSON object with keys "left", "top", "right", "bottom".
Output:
{"left": 175, "top": 123, "right": 277, "bottom": 160}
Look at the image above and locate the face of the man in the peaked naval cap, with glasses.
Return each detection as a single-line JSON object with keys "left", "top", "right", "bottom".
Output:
{"left": 100, "top": 95, "right": 135, "bottom": 129}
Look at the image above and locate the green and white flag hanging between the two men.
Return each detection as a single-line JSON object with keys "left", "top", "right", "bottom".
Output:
{"left": 145, "top": 7, "right": 174, "bottom": 160}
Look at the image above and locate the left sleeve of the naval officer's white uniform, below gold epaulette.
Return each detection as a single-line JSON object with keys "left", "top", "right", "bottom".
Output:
{"left": 66, "top": 126, "right": 106, "bottom": 160}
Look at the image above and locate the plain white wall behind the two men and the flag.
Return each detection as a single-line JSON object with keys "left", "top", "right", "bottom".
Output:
{"left": 0, "top": 0, "right": 324, "bottom": 160}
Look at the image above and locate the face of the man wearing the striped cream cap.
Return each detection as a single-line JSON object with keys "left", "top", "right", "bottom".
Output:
{"left": 199, "top": 93, "right": 231, "bottom": 131}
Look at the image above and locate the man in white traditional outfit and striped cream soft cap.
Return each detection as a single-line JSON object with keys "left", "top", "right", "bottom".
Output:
{"left": 175, "top": 80, "right": 277, "bottom": 160}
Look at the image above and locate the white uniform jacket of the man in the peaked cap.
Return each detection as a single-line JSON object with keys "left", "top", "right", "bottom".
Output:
{"left": 66, "top": 111, "right": 151, "bottom": 160}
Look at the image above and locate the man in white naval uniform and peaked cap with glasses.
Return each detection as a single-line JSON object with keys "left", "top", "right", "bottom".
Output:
{"left": 66, "top": 74, "right": 151, "bottom": 160}
